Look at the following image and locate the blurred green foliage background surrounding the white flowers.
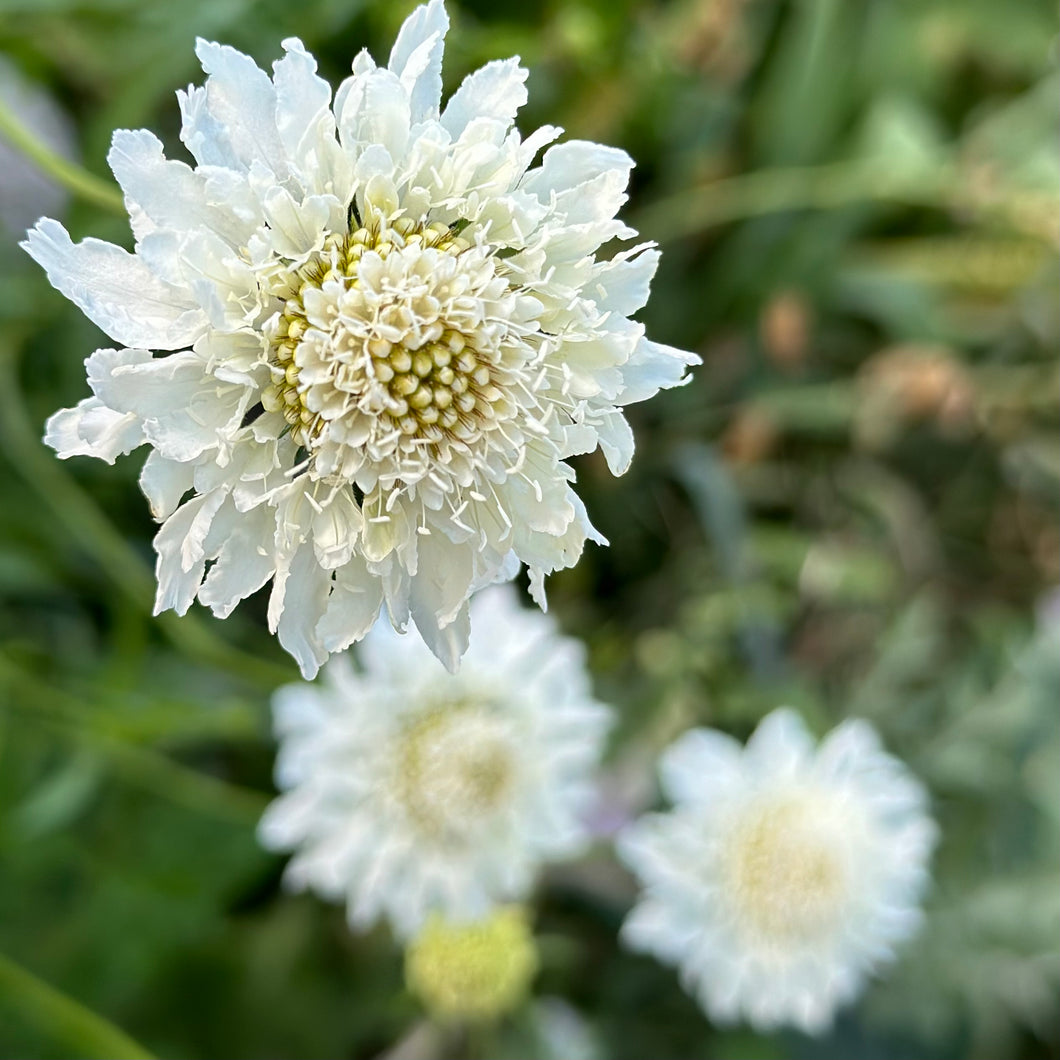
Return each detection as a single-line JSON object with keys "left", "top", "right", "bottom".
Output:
{"left": 0, "top": 0, "right": 1060, "bottom": 1060}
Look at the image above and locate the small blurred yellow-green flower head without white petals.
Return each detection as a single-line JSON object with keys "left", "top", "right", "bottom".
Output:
{"left": 405, "top": 905, "right": 537, "bottom": 1022}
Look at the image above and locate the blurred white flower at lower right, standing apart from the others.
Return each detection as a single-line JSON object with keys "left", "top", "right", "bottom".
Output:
{"left": 618, "top": 708, "right": 936, "bottom": 1034}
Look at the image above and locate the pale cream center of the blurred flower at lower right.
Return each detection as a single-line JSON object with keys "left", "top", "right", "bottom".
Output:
{"left": 724, "top": 801, "right": 845, "bottom": 941}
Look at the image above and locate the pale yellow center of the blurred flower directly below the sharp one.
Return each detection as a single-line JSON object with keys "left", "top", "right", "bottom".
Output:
{"left": 395, "top": 705, "right": 514, "bottom": 837}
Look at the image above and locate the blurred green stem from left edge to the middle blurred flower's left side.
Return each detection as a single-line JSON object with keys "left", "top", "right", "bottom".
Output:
{"left": 0, "top": 654, "right": 268, "bottom": 825}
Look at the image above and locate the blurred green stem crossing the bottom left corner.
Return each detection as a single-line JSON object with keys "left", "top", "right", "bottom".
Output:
{"left": 0, "top": 954, "right": 154, "bottom": 1060}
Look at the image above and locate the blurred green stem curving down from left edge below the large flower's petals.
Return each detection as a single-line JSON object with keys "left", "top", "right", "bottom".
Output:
{"left": 0, "top": 345, "right": 294, "bottom": 689}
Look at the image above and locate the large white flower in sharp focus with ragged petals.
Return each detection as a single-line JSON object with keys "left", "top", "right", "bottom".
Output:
{"left": 23, "top": 0, "right": 699, "bottom": 676}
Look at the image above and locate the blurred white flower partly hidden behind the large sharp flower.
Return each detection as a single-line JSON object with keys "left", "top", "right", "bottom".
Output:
{"left": 259, "top": 586, "right": 610, "bottom": 936}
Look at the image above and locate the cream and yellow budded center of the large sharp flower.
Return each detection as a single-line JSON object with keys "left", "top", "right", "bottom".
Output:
{"left": 262, "top": 217, "right": 511, "bottom": 460}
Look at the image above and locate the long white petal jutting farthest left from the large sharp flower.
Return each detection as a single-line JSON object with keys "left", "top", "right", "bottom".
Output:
{"left": 21, "top": 217, "right": 207, "bottom": 350}
